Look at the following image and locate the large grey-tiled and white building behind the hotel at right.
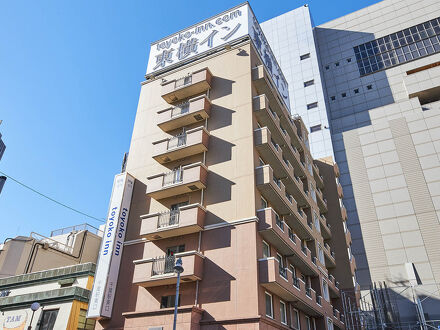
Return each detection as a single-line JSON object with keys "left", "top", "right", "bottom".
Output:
{"left": 262, "top": 0, "right": 440, "bottom": 327}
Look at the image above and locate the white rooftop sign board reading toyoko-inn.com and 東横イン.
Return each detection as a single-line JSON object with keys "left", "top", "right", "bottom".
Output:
{"left": 147, "top": 3, "right": 290, "bottom": 110}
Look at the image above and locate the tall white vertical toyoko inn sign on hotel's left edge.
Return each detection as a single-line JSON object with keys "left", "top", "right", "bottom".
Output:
{"left": 87, "top": 173, "right": 134, "bottom": 319}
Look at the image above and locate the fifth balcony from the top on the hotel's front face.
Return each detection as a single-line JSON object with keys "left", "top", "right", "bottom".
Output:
{"left": 140, "top": 204, "right": 206, "bottom": 241}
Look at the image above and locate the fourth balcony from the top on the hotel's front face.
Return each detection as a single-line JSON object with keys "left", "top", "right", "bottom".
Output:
{"left": 147, "top": 163, "right": 208, "bottom": 199}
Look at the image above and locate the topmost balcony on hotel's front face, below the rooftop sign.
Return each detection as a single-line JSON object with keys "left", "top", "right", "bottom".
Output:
{"left": 161, "top": 68, "right": 212, "bottom": 103}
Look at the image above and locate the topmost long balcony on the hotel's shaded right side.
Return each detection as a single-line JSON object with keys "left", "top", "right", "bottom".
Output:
{"left": 252, "top": 65, "right": 302, "bottom": 149}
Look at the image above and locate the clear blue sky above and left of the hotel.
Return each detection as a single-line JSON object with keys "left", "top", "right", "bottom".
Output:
{"left": 0, "top": 0, "right": 378, "bottom": 242}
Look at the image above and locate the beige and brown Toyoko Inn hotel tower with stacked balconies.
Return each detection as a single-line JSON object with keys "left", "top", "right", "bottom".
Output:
{"left": 88, "top": 3, "right": 356, "bottom": 330}
